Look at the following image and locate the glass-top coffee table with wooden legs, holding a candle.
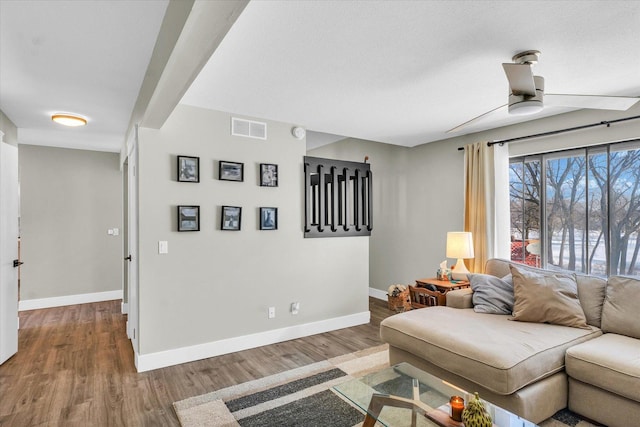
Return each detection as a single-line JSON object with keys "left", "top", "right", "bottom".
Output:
{"left": 333, "top": 363, "right": 536, "bottom": 427}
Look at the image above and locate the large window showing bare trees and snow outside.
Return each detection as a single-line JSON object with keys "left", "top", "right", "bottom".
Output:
{"left": 509, "top": 140, "right": 640, "bottom": 277}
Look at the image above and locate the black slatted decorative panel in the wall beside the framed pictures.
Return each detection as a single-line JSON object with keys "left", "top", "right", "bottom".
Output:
{"left": 304, "top": 156, "right": 373, "bottom": 237}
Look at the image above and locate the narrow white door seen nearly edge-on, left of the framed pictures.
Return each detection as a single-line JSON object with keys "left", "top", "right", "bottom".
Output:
{"left": 127, "top": 131, "right": 139, "bottom": 354}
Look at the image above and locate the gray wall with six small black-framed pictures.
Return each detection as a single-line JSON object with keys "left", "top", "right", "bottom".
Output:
{"left": 139, "top": 105, "right": 369, "bottom": 355}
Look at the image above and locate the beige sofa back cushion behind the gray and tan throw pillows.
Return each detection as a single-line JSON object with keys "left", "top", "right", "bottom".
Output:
{"left": 485, "top": 258, "right": 607, "bottom": 328}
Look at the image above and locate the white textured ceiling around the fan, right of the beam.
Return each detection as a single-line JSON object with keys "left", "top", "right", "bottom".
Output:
{"left": 182, "top": 1, "right": 640, "bottom": 146}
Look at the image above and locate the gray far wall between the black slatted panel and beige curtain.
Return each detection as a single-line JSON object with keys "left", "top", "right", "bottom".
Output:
{"left": 309, "top": 138, "right": 463, "bottom": 291}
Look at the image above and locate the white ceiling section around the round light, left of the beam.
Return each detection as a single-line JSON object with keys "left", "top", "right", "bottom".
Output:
{"left": 0, "top": 0, "right": 168, "bottom": 151}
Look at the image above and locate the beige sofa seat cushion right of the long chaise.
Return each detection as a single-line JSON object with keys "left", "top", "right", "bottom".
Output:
{"left": 566, "top": 334, "right": 640, "bottom": 402}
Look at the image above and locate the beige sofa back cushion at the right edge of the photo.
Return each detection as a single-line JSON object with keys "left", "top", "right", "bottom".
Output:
{"left": 602, "top": 276, "right": 640, "bottom": 338}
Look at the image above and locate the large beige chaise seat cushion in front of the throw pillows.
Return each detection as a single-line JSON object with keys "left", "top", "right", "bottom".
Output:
{"left": 380, "top": 307, "right": 602, "bottom": 395}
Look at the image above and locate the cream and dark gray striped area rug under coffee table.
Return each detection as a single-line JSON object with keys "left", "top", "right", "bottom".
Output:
{"left": 173, "top": 345, "right": 594, "bottom": 427}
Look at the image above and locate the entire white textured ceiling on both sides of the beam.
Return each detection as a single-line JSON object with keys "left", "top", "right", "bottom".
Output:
{"left": 0, "top": 0, "right": 640, "bottom": 151}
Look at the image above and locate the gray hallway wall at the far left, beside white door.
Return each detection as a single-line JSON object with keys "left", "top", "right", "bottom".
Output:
{"left": 19, "top": 145, "right": 123, "bottom": 300}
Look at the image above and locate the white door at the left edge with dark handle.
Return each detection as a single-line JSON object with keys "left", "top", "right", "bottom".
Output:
{"left": 0, "top": 139, "right": 18, "bottom": 364}
